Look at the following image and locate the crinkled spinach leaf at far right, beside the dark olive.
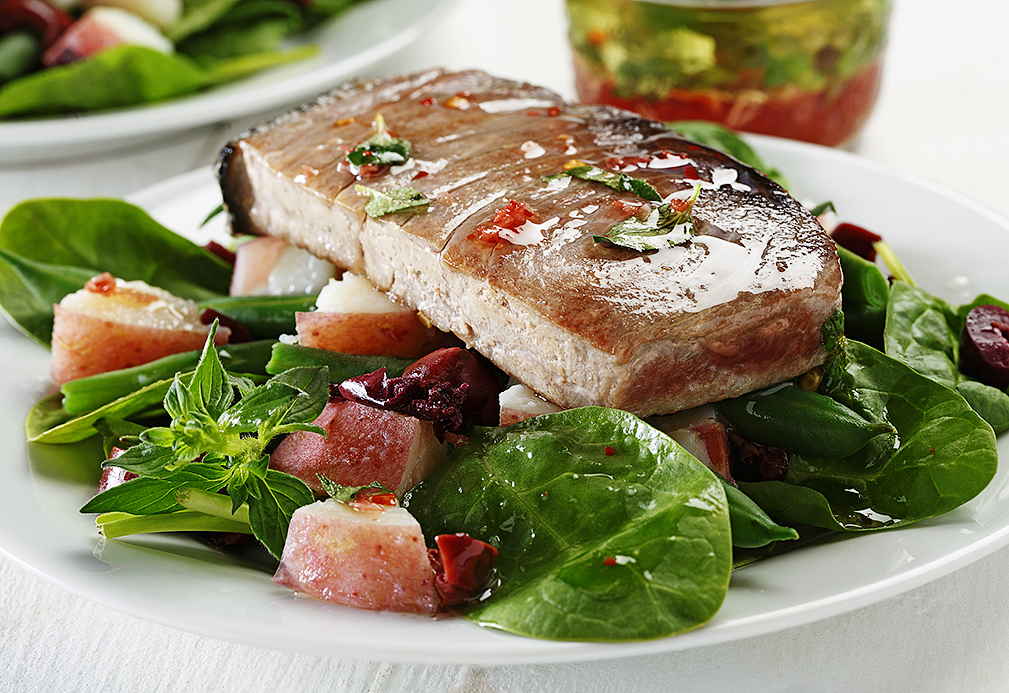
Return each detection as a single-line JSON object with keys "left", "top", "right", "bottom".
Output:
{"left": 885, "top": 281, "right": 1009, "bottom": 433}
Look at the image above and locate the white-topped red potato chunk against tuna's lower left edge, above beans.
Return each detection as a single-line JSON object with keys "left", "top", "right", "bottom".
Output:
{"left": 295, "top": 273, "right": 456, "bottom": 358}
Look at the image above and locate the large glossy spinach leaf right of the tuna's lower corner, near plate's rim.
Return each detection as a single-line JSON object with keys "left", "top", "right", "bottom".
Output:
{"left": 740, "top": 341, "right": 998, "bottom": 531}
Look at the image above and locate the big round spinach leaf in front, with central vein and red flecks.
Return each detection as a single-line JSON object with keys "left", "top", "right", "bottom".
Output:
{"left": 404, "top": 408, "right": 732, "bottom": 642}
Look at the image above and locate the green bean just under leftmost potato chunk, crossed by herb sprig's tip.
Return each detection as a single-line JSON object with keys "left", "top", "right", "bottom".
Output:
{"left": 61, "top": 340, "right": 273, "bottom": 414}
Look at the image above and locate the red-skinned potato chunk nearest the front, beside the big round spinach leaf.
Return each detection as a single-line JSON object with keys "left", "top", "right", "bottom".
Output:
{"left": 273, "top": 499, "right": 438, "bottom": 615}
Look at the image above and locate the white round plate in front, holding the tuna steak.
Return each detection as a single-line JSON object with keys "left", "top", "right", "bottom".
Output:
{"left": 0, "top": 137, "right": 1009, "bottom": 665}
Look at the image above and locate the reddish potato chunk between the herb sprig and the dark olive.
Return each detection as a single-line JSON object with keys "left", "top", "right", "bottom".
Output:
{"left": 270, "top": 398, "right": 448, "bottom": 493}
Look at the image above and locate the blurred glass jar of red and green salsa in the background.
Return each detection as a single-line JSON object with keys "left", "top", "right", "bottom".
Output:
{"left": 566, "top": 0, "right": 891, "bottom": 146}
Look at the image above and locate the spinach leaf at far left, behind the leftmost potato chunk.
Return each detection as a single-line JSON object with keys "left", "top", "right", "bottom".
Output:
{"left": 0, "top": 199, "right": 231, "bottom": 346}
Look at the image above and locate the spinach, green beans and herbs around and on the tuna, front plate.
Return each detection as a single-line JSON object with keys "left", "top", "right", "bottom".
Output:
{"left": 0, "top": 123, "right": 1009, "bottom": 642}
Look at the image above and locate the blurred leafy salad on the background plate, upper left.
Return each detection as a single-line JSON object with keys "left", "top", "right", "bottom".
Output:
{"left": 0, "top": 0, "right": 363, "bottom": 119}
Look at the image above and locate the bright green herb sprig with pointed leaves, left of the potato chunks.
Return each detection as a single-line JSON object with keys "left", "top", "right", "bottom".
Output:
{"left": 81, "top": 323, "right": 329, "bottom": 557}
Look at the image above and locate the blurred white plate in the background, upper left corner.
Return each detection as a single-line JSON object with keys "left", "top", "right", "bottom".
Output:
{"left": 0, "top": 0, "right": 453, "bottom": 162}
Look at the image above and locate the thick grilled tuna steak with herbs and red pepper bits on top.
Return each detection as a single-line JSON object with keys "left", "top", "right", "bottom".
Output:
{"left": 219, "top": 71, "right": 840, "bottom": 416}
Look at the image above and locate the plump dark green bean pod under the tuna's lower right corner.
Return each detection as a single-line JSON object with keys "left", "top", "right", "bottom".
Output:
{"left": 714, "top": 382, "right": 894, "bottom": 458}
